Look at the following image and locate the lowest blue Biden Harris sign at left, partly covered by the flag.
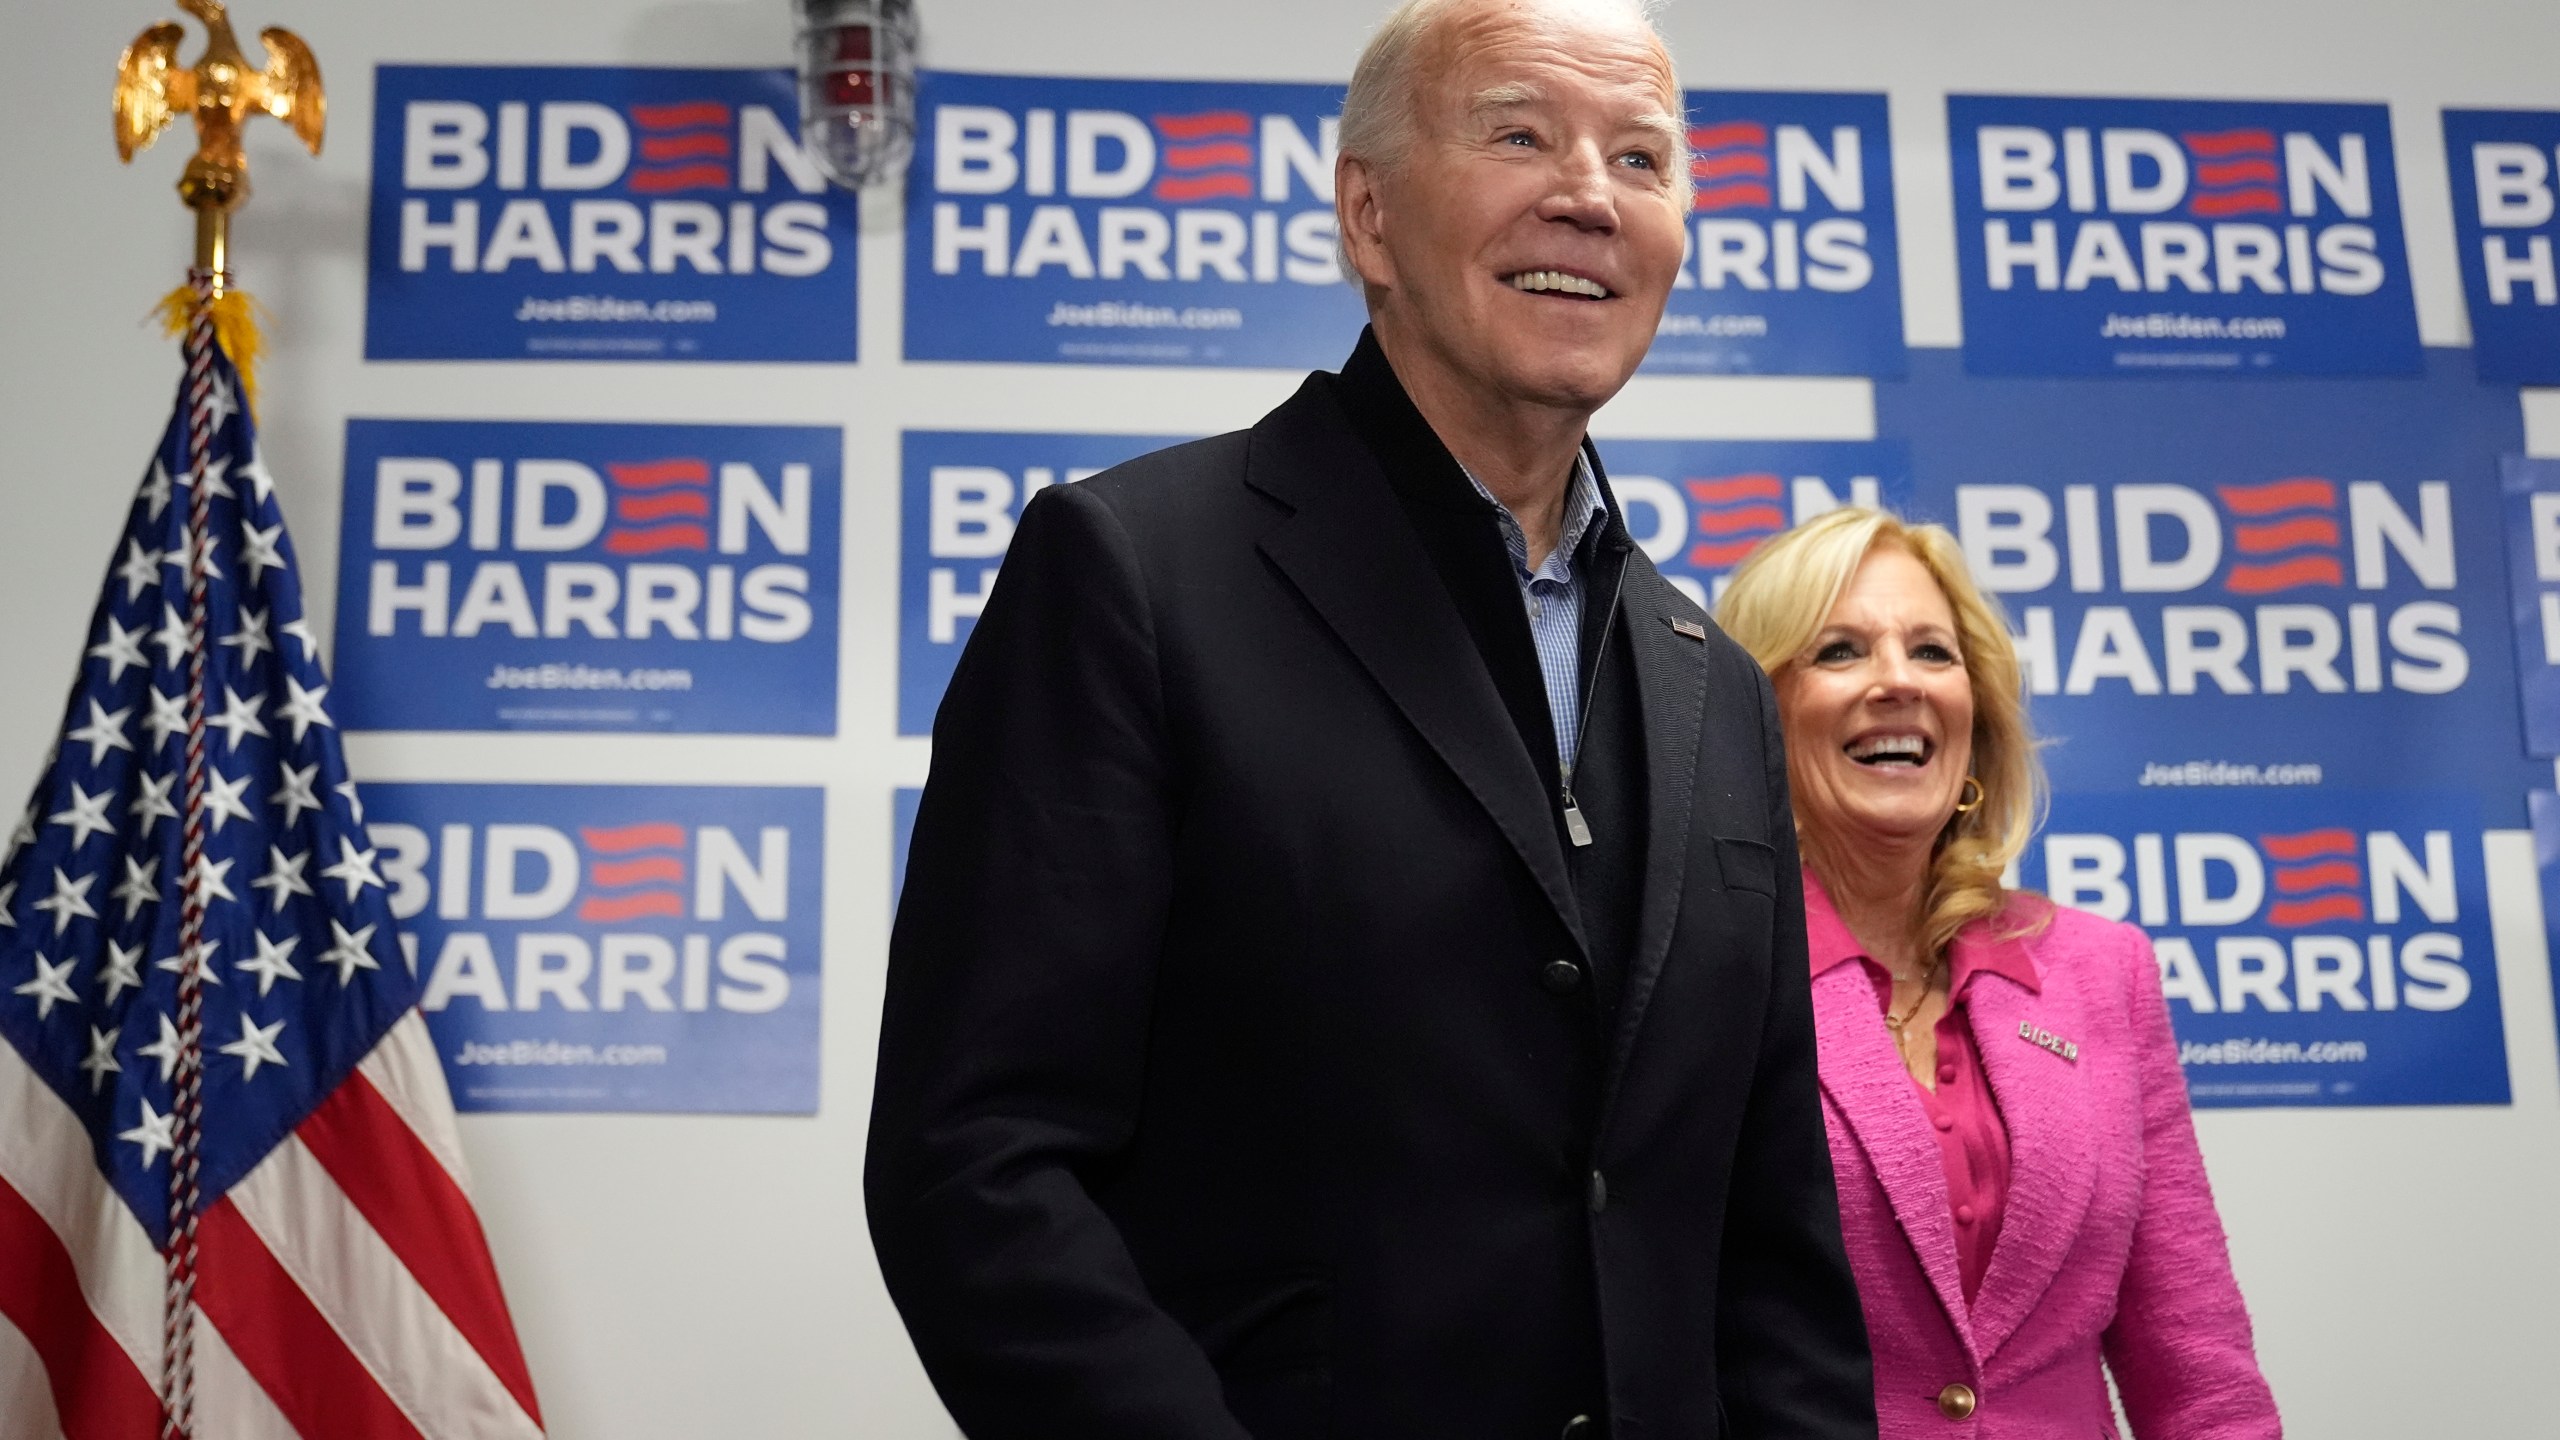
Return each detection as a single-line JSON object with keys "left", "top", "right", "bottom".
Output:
{"left": 364, "top": 784, "right": 824, "bottom": 1115}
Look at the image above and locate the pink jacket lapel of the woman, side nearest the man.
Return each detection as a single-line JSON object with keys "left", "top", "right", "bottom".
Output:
{"left": 1812, "top": 961, "right": 1997, "bottom": 1355}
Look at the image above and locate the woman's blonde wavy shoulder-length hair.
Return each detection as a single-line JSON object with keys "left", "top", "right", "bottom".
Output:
{"left": 1715, "top": 505, "right": 2045, "bottom": 956}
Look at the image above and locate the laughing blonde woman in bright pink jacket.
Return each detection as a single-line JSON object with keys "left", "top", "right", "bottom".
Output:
{"left": 1718, "top": 507, "right": 2281, "bottom": 1440}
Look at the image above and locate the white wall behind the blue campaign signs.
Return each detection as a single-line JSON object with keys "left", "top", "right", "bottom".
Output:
{"left": 0, "top": 0, "right": 2560, "bottom": 1440}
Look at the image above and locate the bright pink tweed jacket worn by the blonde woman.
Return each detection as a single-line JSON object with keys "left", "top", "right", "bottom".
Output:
{"left": 1812, "top": 899, "right": 2284, "bottom": 1440}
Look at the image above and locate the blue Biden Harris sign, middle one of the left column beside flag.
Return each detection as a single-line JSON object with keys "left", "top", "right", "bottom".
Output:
{"left": 333, "top": 420, "right": 845, "bottom": 735}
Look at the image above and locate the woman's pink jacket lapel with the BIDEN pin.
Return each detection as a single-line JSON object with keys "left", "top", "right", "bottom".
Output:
{"left": 1966, "top": 976, "right": 2097, "bottom": 1355}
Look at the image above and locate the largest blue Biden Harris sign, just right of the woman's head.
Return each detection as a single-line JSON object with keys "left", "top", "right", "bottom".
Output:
{"left": 1876, "top": 351, "right": 2547, "bottom": 825}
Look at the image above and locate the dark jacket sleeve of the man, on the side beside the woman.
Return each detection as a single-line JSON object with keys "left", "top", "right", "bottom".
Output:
{"left": 1715, "top": 666, "right": 1876, "bottom": 1440}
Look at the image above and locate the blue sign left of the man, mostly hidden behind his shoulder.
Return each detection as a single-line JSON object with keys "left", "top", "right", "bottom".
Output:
{"left": 899, "top": 430, "right": 1183, "bottom": 735}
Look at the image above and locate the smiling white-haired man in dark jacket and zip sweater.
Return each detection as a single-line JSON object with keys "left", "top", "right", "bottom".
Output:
{"left": 865, "top": 0, "right": 1874, "bottom": 1440}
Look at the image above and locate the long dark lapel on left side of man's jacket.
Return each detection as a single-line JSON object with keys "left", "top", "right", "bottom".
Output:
{"left": 1244, "top": 377, "right": 1587, "bottom": 956}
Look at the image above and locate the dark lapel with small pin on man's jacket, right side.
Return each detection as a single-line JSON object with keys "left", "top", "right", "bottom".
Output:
{"left": 1592, "top": 548, "right": 1708, "bottom": 1092}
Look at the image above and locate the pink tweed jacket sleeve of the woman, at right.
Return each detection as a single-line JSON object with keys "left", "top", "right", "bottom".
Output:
{"left": 2104, "top": 933, "right": 2284, "bottom": 1440}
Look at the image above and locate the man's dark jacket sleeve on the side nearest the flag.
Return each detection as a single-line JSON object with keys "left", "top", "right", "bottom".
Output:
{"left": 863, "top": 484, "right": 1244, "bottom": 1440}
